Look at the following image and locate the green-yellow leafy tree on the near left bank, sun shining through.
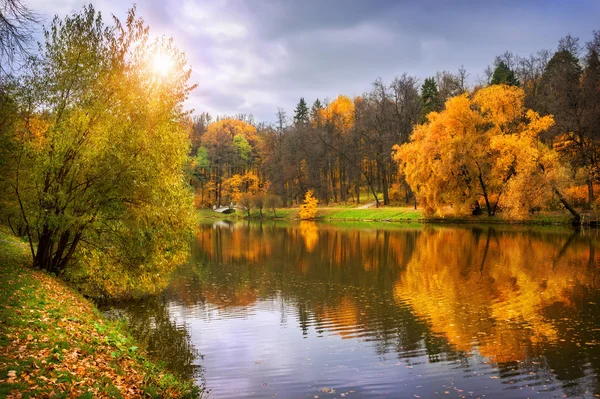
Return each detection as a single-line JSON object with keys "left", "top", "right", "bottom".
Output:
{"left": 3, "top": 5, "right": 193, "bottom": 295}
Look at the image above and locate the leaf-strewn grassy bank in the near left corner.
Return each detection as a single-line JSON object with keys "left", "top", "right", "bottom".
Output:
{"left": 0, "top": 227, "right": 200, "bottom": 398}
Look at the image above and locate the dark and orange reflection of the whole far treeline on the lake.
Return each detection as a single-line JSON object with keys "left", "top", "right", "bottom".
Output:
{"left": 189, "top": 224, "right": 600, "bottom": 395}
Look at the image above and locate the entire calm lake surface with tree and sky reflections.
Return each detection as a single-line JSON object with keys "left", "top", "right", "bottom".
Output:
{"left": 105, "top": 221, "right": 600, "bottom": 398}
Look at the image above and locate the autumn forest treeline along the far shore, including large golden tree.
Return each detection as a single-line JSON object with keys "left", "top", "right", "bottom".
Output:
{"left": 190, "top": 31, "right": 600, "bottom": 222}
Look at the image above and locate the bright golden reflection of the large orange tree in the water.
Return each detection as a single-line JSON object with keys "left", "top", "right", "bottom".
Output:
{"left": 394, "top": 229, "right": 596, "bottom": 362}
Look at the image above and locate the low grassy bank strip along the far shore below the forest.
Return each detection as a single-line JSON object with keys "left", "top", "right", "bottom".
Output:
{"left": 197, "top": 208, "right": 573, "bottom": 226}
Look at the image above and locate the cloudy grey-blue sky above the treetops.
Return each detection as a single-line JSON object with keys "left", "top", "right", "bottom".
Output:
{"left": 26, "top": 0, "right": 600, "bottom": 121}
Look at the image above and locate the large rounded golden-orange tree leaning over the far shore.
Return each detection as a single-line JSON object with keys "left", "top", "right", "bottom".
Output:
{"left": 394, "top": 85, "right": 578, "bottom": 222}
